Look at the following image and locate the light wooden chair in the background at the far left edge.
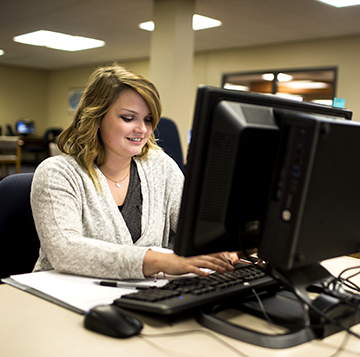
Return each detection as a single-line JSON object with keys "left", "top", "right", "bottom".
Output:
{"left": 0, "top": 136, "right": 22, "bottom": 177}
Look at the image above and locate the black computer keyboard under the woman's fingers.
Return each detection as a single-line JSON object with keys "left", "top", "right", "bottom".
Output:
{"left": 114, "top": 263, "right": 275, "bottom": 315}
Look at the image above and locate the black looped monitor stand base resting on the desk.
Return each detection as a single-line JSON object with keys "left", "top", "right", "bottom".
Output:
{"left": 197, "top": 264, "right": 360, "bottom": 349}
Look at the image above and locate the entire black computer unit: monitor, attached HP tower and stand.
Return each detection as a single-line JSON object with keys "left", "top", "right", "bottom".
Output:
{"left": 174, "top": 86, "right": 360, "bottom": 347}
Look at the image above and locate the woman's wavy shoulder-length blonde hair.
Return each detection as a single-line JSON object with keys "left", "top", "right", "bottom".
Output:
{"left": 58, "top": 63, "right": 161, "bottom": 189}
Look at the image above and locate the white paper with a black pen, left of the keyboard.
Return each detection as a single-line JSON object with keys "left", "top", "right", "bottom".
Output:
{"left": 11, "top": 270, "right": 167, "bottom": 312}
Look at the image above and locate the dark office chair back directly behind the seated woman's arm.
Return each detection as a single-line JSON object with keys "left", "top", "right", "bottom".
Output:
{"left": 0, "top": 173, "right": 40, "bottom": 279}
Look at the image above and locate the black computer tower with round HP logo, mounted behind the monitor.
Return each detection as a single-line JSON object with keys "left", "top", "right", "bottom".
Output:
{"left": 259, "top": 111, "right": 360, "bottom": 270}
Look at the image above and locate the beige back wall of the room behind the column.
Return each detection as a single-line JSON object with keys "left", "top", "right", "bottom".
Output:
{"left": 0, "top": 36, "right": 360, "bottom": 156}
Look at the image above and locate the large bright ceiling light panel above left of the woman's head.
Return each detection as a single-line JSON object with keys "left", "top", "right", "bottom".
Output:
{"left": 14, "top": 30, "right": 105, "bottom": 51}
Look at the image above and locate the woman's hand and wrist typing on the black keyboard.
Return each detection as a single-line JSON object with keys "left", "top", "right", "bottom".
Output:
{"left": 143, "top": 249, "right": 239, "bottom": 276}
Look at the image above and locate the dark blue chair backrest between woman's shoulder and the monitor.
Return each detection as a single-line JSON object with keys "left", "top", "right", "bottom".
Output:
{"left": 154, "top": 117, "right": 184, "bottom": 171}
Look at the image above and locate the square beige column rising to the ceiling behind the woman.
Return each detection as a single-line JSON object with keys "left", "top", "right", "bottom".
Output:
{"left": 150, "top": 0, "right": 195, "bottom": 157}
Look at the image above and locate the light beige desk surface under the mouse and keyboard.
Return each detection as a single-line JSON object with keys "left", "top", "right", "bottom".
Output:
{"left": 0, "top": 257, "right": 360, "bottom": 357}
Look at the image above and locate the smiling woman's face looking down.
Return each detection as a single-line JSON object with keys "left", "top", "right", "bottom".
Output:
{"left": 100, "top": 89, "right": 152, "bottom": 159}
